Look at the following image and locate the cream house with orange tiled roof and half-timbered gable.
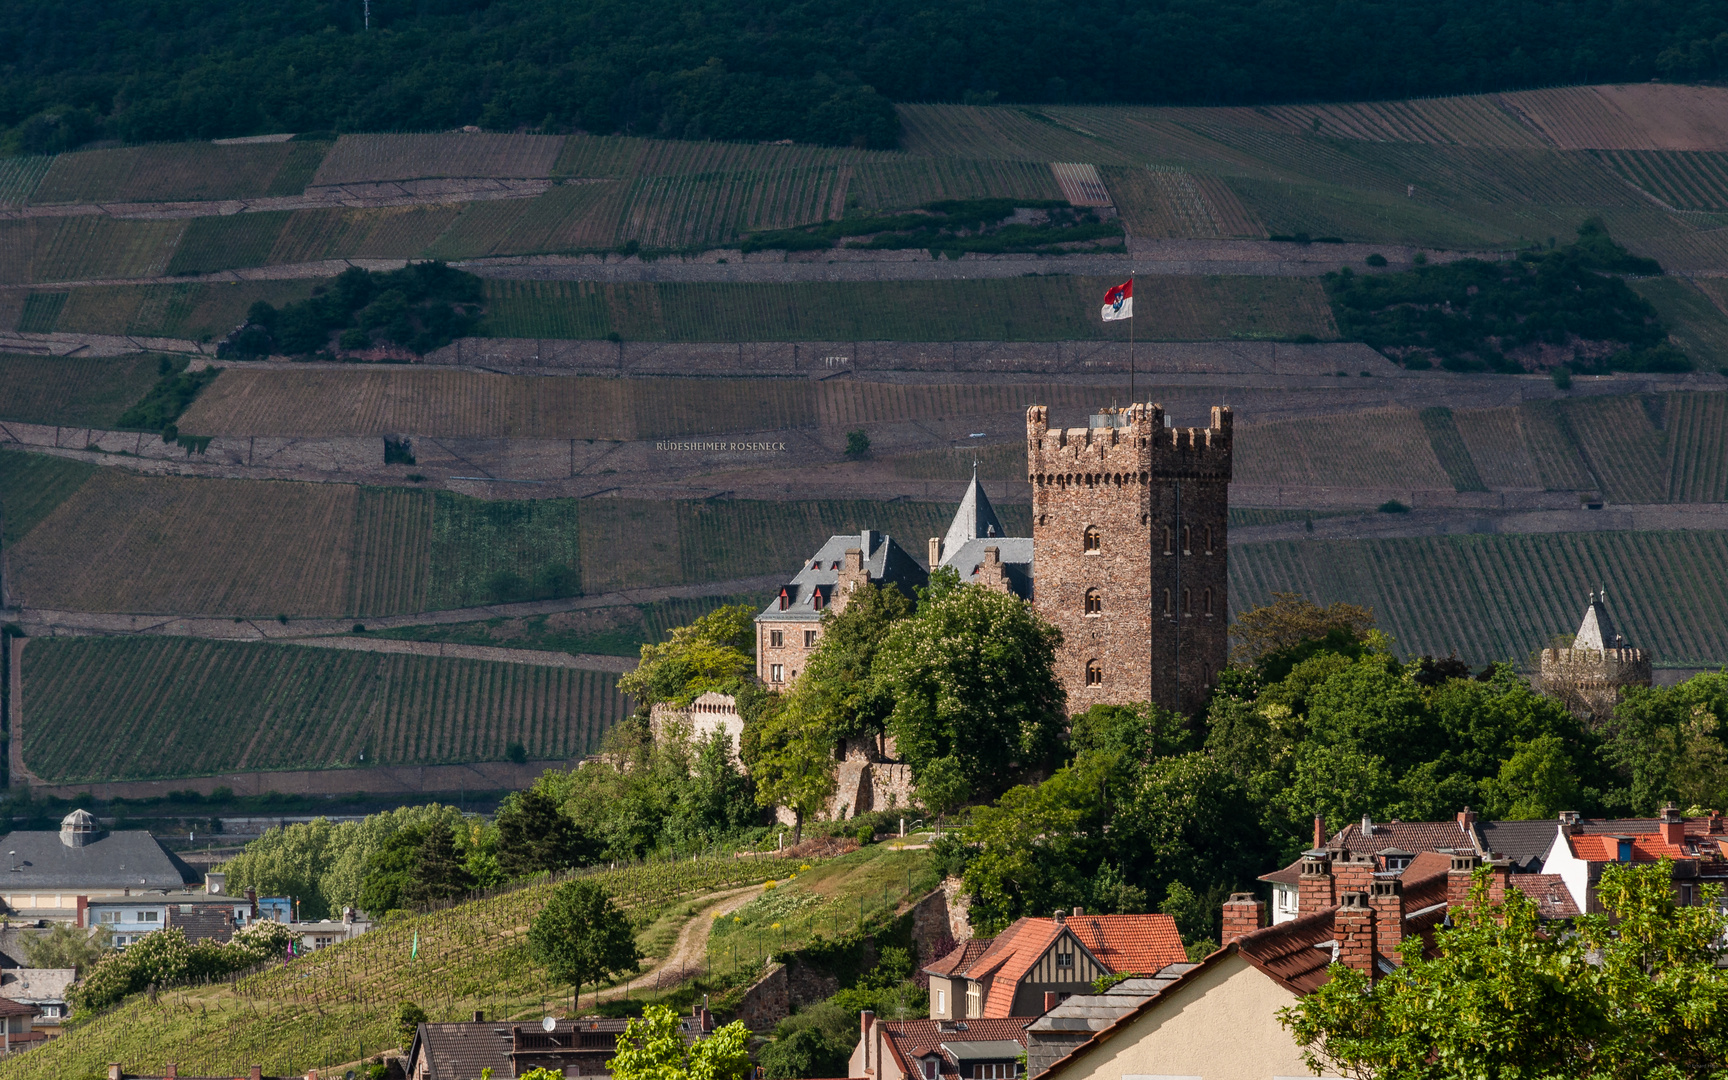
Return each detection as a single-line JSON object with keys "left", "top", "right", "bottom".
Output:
{"left": 924, "top": 907, "right": 1187, "bottom": 1020}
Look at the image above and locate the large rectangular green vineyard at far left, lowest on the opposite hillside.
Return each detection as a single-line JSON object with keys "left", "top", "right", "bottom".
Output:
{"left": 22, "top": 638, "right": 627, "bottom": 783}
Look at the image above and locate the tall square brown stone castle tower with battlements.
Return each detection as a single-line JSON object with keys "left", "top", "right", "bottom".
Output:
{"left": 1026, "top": 404, "right": 1230, "bottom": 714}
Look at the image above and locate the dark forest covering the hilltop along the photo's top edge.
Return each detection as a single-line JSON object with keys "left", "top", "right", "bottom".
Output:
{"left": 0, "top": 0, "right": 1728, "bottom": 152}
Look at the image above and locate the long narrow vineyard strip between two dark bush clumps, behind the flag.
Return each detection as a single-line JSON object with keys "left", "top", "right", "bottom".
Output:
{"left": 482, "top": 276, "right": 1337, "bottom": 342}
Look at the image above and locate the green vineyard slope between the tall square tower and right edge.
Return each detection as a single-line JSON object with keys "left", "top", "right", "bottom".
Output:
{"left": 1230, "top": 532, "right": 1728, "bottom": 664}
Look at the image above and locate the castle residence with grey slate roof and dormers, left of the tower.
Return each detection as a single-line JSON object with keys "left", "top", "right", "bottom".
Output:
{"left": 755, "top": 529, "right": 930, "bottom": 689}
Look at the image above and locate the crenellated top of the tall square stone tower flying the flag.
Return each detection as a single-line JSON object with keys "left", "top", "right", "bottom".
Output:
{"left": 1026, "top": 404, "right": 1232, "bottom": 486}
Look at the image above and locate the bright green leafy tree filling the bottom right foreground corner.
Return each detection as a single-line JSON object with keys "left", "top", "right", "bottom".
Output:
{"left": 1279, "top": 859, "right": 1728, "bottom": 1080}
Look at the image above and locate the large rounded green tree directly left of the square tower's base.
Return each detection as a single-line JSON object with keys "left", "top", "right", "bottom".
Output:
{"left": 876, "top": 569, "right": 1064, "bottom": 797}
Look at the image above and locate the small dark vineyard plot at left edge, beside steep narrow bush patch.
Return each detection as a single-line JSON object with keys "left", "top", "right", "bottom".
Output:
{"left": 0, "top": 354, "right": 157, "bottom": 427}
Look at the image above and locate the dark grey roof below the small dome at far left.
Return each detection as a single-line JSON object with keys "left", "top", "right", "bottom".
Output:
{"left": 0, "top": 829, "right": 204, "bottom": 892}
